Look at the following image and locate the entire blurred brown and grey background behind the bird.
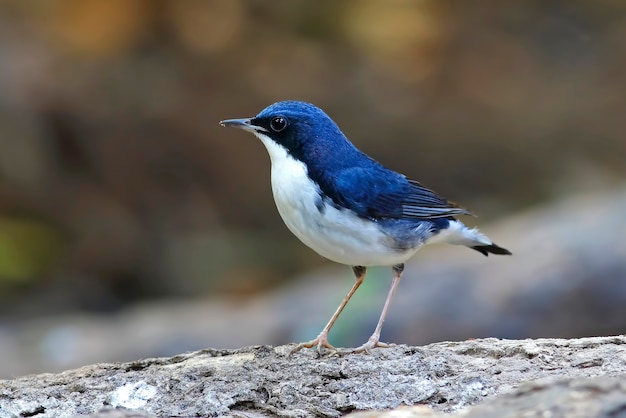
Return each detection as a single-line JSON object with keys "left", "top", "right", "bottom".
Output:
{"left": 0, "top": 0, "right": 626, "bottom": 378}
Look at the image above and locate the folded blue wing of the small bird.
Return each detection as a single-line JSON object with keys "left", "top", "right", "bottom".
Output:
{"left": 320, "top": 164, "right": 471, "bottom": 219}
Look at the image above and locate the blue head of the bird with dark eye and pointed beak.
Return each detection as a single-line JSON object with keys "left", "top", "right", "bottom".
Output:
{"left": 220, "top": 100, "right": 355, "bottom": 162}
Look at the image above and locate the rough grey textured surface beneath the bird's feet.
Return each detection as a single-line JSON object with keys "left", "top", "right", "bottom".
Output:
{"left": 0, "top": 336, "right": 626, "bottom": 418}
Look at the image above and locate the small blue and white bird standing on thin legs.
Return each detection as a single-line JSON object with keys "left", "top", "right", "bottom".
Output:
{"left": 220, "top": 101, "right": 511, "bottom": 354}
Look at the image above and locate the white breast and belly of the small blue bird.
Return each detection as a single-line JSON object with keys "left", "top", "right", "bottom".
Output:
{"left": 256, "top": 133, "right": 418, "bottom": 266}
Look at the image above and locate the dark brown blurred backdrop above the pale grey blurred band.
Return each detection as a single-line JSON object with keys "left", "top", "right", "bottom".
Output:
{"left": 0, "top": 0, "right": 626, "bottom": 378}
